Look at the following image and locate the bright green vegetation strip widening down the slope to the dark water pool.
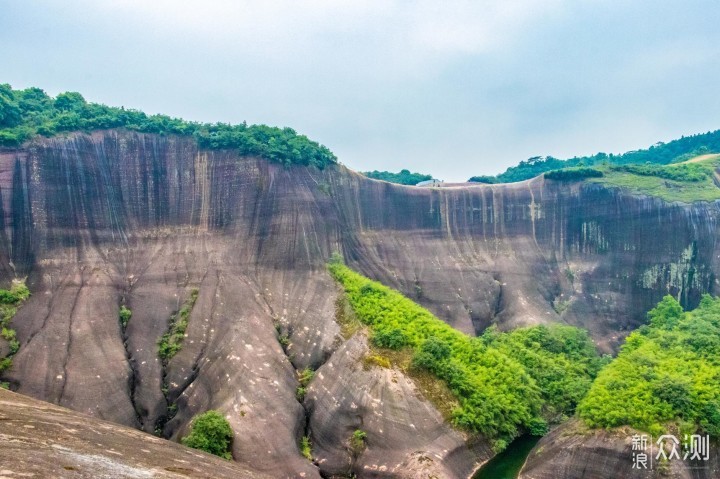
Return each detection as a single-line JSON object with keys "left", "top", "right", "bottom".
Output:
{"left": 329, "top": 261, "right": 604, "bottom": 450}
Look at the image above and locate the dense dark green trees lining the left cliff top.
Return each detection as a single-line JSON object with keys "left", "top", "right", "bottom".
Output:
{"left": 0, "top": 85, "right": 337, "bottom": 168}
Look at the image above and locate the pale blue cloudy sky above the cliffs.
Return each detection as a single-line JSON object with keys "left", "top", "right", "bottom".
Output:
{"left": 0, "top": 0, "right": 720, "bottom": 180}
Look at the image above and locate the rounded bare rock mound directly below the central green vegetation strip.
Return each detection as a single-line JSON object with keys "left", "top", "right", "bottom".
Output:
{"left": 305, "top": 334, "right": 492, "bottom": 479}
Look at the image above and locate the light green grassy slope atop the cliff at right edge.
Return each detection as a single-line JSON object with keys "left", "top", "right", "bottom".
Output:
{"left": 587, "top": 155, "right": 720, "bottom": 203}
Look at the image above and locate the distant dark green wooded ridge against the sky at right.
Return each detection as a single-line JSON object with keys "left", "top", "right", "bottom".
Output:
{"left": 468, "top": 130, "right": 720, "bottom": 183}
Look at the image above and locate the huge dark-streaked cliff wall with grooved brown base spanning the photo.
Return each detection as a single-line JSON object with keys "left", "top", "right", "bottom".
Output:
{"left": 0, "top": 131, "right": 720, "bottom": 477}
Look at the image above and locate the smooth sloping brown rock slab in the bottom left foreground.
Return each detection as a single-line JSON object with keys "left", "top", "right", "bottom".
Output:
{"left": 0, "top": 389, "right": 271, "bottom": 479}
